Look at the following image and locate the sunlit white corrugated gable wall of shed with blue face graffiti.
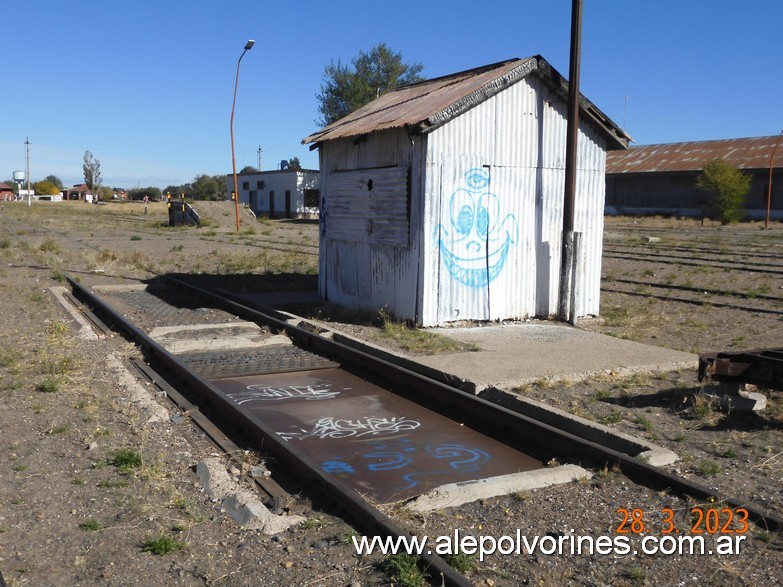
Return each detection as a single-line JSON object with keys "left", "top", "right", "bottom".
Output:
{"left": 421, "top": 76, "right": 605, "bottom": 325}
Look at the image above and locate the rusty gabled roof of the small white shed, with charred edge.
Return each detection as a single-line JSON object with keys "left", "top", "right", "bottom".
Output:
{"left": 302, "top": 55, "right": 630, "bottom": 149}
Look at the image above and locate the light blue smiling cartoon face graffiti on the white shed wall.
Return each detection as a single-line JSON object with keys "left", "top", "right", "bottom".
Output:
{"left": 435, "top": 168, "right": 518, "bottom": 288}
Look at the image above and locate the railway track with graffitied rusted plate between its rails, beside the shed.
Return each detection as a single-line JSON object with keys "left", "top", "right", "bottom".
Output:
{"left": 69, "top": 278, "right": 783, "bottom": 585}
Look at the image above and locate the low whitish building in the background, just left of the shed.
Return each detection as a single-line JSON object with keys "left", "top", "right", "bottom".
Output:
{"left": 226, "top": 169, "right": 320, "bottom": 218}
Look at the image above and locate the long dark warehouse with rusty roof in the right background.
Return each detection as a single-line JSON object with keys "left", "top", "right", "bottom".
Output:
{"left": 606, "top": 136, "right": 783, "bottom": 219}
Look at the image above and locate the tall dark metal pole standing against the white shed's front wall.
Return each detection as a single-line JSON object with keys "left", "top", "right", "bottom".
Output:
{"left": 558, "top": 0, "right": 582, "bottom": 321}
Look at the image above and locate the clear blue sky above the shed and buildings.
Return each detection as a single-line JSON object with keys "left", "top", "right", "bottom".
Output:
{"left": 0, "top": 0, "right": 783, "bottom": 188}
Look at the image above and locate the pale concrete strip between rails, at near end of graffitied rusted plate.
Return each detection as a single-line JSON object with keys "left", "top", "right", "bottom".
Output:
{"left": 405, "top": 464, "right": 593, "bottom": 512}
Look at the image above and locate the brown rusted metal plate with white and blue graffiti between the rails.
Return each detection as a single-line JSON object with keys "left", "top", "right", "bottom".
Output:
{"left": 211, "top": 369, "right": 544, "bottom": 503}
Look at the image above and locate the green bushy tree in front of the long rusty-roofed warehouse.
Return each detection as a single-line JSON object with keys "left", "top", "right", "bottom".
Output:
{"left": 696, "top": 159, "right": 751, "bottom": 224}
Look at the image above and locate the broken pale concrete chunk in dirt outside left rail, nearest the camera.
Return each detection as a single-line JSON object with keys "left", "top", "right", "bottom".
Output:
{"left": 196, "top": 457, "right": 307, "bottom": 534}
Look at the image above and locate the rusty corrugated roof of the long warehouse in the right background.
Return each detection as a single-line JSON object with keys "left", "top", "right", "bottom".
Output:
{"left": 606, "top": 136, "right": 783, "bottom": 174}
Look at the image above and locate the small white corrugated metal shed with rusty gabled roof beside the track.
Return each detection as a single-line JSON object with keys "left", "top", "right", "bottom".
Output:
{"left": 303, "top": 56, "right": 629, "bottom": 326}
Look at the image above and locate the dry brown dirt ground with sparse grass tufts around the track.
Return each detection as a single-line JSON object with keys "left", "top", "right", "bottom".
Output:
{"left": 0, "top": 202, "right": 783, "bottom": 587}
